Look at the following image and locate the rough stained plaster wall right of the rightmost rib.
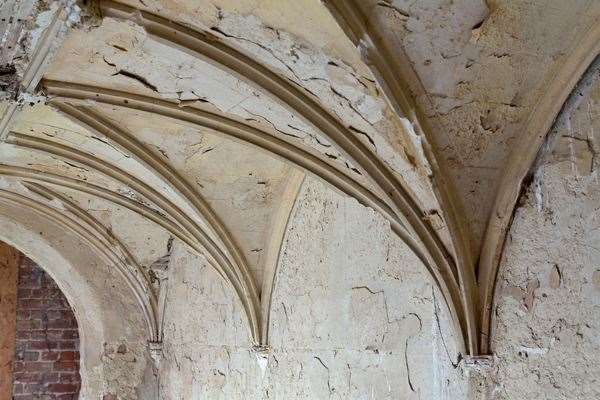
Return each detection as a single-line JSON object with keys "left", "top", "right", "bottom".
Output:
{"left": 489, "top": 55, "right": 600, "bottom": 399}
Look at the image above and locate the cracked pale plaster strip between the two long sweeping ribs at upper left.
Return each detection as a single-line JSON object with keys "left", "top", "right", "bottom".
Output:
{"left": 100, "top": 18, "right": 352, "bottom": 172}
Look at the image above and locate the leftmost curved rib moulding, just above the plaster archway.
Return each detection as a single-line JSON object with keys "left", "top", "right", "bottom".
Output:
{"left": 0, "top": 183, "right": 161, "bottom": 341}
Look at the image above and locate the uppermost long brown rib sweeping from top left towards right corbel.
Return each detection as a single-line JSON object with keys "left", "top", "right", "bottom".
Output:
{"left": 100, "top": 0, "right": 464, "bottom": 326}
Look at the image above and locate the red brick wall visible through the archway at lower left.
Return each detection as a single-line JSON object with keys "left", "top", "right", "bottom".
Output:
{"left": 13, "top": 257, "right": 81, "bottom": 400}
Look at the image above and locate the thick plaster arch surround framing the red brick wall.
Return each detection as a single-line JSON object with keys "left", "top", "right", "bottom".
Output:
{"left": 0, "top": 203, "right": 155, "bottom": 399}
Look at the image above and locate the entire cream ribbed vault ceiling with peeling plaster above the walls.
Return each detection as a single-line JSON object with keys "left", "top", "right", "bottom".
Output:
{"left": 0, "top": 0, "right": 600, "bottom": 396}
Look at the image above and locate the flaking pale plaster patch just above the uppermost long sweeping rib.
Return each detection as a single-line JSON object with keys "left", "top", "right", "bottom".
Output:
{"left": 213, "top": 12, "right": 440, "bottom": 186}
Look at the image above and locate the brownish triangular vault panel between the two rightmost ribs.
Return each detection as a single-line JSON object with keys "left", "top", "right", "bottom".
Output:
{"left": 365, "top": 0, "right": 600, "bottom": 254}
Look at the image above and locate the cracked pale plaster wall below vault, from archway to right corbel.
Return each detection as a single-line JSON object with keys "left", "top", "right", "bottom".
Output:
{"left": 159, "top": 179, "right": 466, "bottom": 399}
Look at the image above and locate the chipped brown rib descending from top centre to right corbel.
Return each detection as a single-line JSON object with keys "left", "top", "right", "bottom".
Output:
{"left": 323, "top": 0, "right": 479, "bottom": 355}
